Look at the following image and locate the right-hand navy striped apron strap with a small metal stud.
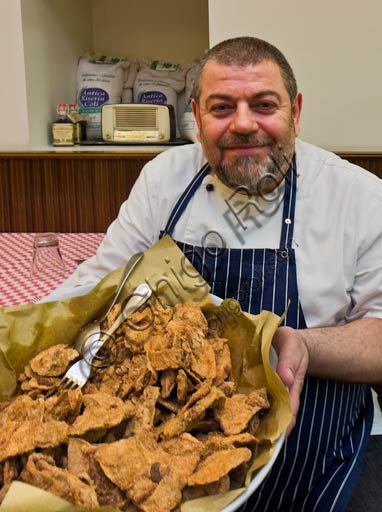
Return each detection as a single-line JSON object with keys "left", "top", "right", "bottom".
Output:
{"left": 280, "top": 155, "right": 297, "bottom": 249}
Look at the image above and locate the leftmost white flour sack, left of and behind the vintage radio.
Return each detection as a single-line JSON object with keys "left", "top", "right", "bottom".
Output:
{"left": 77, "top": 55, "right": 129, "bottom": 140}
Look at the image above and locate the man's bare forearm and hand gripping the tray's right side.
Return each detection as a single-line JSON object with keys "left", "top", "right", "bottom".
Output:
{"left": 272, "top": 317, "right": 382, "bottom": 434}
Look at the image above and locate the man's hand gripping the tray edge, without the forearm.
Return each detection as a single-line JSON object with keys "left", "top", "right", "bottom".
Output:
{"left": 272, "top": 327, "right": 309, "bottom": 436}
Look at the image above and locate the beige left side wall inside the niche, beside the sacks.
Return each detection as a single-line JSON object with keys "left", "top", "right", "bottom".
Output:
{"left": 21, "top": 0, "right": 93, "bottom": 146}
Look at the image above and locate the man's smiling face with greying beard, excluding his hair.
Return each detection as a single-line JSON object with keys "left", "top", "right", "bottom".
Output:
{"left": 193, "top": 60, "right": 302, "bottom": 194}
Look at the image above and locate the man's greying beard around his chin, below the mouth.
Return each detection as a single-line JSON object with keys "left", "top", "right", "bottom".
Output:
{"left": 214, "top": 151, "right": 292, "bottom": 196}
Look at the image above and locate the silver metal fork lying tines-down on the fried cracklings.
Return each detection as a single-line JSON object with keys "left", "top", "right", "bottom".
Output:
{"left": 45, "top": 283, "right": 152, "bottom": 397}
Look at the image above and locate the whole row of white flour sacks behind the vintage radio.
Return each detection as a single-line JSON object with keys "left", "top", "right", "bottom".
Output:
{"left": 77, "top": 52, "right": 201, "bottom": 142}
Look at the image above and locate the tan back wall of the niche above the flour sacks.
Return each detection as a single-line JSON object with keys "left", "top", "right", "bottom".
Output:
{"left": 92, "top": 0, "right": 208, "bottom": 63}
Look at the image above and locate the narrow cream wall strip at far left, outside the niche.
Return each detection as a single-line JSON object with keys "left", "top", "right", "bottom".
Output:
{"left": 0, "top": 0, "right": 29, "bottom": 148}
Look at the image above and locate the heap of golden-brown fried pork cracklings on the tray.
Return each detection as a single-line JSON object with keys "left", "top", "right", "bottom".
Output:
{"left": 0, "top": 299, "right": 269, "bottom": 512}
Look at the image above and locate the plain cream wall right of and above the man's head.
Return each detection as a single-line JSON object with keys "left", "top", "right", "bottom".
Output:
{"left": 209, "top": 0, "right": 382, "bottom": 151}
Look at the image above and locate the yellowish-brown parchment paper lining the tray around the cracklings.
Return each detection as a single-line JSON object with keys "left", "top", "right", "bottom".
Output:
{"left": 0, "top": 237, "right": 291, "bottom": 512}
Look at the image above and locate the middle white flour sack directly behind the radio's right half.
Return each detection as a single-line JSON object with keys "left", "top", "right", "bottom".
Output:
{"left": 134, "top": 60, "right": 189, "bottom": 137}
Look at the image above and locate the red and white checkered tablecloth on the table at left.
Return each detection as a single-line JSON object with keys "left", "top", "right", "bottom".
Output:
{"left": 0, "top": 233, "right": 104, "bottom": 306}
